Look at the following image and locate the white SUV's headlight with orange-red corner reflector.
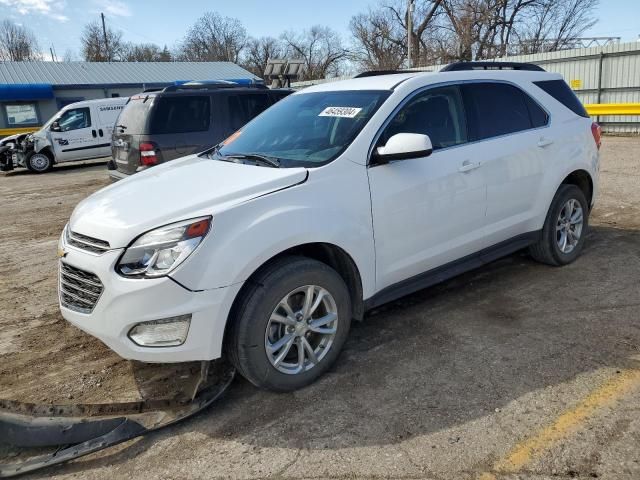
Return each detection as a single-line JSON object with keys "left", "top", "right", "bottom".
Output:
{"left": 116, "top": 217, "right": 211, "bottom": 278}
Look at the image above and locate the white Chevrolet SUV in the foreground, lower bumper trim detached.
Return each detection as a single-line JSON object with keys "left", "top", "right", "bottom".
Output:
{"left": 59, "top": 65, "right": 600, "bottom": 391}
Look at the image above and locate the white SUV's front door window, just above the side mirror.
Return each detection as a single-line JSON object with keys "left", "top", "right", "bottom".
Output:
{"left": 378, "top": 86, "right": 468, "bottom": 150}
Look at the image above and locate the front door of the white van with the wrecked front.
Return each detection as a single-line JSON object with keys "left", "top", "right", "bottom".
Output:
{"left": 51, "top": 107, "right": 104, "bottom": 162}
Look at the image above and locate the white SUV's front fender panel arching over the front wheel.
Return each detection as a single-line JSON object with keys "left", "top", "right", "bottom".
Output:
{"left": 171, "top": 160, "right": 375, "bottom": 298}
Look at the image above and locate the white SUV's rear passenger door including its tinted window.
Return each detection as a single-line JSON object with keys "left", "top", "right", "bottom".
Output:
{"left": 461, "top": 82, "right": 553, "bottom": 245}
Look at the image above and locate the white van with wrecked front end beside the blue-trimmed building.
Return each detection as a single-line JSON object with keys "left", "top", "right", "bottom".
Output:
{"left": 2, "top": 97, "right": 128, "bottom": 173}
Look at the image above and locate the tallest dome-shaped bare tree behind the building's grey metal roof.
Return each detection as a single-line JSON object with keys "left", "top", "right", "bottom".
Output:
{"left": 180, "top": 12, "right": 247, "bottom": 63}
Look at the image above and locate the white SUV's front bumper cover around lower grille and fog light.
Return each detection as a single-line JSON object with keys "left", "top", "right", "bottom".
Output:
{"left": 60, "top": 246, "right": 242, "bottom": 363}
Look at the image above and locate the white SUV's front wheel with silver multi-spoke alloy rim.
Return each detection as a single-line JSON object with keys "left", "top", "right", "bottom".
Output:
{"left": 225, "top": 256, "right": 351, "bottom": 392}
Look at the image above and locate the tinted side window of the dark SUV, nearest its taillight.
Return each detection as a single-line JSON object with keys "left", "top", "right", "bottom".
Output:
{"left": 149, "top": 95, "right": 211, "bottom": 135}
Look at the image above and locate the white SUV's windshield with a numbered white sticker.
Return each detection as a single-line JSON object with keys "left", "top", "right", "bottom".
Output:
{"left": 217, "top": 91, "right": 391, "bottom": 167}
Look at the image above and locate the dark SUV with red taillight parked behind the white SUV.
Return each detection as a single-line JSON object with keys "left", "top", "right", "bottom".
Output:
{"left": 108, "top": 82, "right": 292, "bottom": 181}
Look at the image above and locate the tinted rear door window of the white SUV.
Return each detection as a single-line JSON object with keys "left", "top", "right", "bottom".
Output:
{"left": 462, "top": 83, "right": 533, "bottom": 140}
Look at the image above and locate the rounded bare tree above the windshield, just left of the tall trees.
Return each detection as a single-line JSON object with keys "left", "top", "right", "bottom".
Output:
{"left": 281, "top": 25, "right": 348, "bottom": 79}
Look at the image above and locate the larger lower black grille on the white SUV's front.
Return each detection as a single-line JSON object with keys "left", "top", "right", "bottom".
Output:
{"left": 59, "top": 262, "right": 104, "bottom": 313}
